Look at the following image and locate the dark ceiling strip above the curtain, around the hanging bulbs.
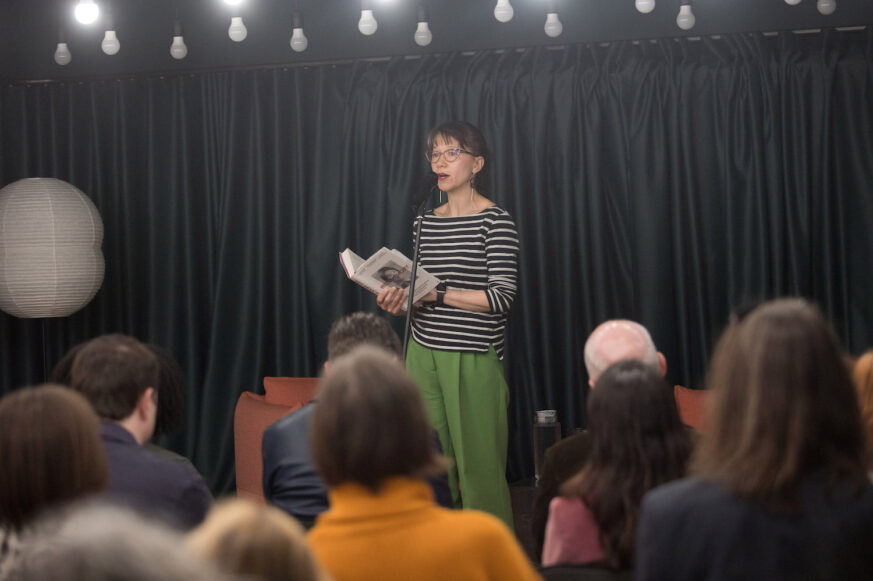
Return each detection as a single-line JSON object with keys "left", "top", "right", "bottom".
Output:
{"left": 0, "top": 0, "right": 873, "bottom": 81}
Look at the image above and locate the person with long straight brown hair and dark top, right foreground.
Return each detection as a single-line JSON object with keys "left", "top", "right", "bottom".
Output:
{"left": 635, "top": 299, "right": 873, "bottom": 581}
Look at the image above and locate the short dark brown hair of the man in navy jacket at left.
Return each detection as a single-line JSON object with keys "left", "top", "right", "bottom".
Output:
{"left": 70, "top": 334, "right": 160, "bottom": 421}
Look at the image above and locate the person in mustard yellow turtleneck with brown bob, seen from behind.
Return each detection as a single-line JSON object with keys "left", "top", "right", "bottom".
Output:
{"left": 307, "top": 346, "right": 540, "bottom": 581}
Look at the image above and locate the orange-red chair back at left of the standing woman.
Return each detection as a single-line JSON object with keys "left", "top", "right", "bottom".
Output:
{"left": 233, "top": 391, "right": 303, "bottom": 503}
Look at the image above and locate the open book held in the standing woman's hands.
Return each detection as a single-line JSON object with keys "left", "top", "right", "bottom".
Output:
{"left": 340, "top": 247, "right": 440, "bottom": 302}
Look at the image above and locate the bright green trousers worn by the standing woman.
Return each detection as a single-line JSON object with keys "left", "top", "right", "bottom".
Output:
{"left": 406, "top": 340, "right": 513, "bottom": 530}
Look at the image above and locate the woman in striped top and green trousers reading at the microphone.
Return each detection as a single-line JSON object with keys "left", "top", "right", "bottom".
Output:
{"left": 377, "top": 121, "right": 518, "bottom": 527}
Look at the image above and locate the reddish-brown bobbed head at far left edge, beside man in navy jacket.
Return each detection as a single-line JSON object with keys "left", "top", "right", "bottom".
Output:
{"left": 0, "top": 384, "right": 107, "bottom": 529}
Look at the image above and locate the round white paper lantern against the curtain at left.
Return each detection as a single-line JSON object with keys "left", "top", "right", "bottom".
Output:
{"left": 0, "top": 178, "right": 104, "bottom": 318}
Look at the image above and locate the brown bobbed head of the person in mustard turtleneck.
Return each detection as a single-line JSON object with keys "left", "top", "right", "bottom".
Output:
{"left": 311, "top": 345, "right": 445, "bottom": 492}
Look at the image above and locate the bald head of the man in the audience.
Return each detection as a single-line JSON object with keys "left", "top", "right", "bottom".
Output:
{"left": 585, "top": 319, "right": 667, "bottom": 387}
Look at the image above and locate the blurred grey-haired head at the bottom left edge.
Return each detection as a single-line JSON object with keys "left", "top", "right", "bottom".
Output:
{"left": 13, "top": 503, "right": 230, "bottom": 581}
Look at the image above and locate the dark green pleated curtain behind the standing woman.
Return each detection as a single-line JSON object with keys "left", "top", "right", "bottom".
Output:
{"left": 0, "top": 31, "right": 873, "bottom": 492}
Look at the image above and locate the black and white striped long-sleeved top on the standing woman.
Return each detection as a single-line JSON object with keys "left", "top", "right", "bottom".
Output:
{"left": 412, "top": 206, "right": 518, "bottom": 359}
